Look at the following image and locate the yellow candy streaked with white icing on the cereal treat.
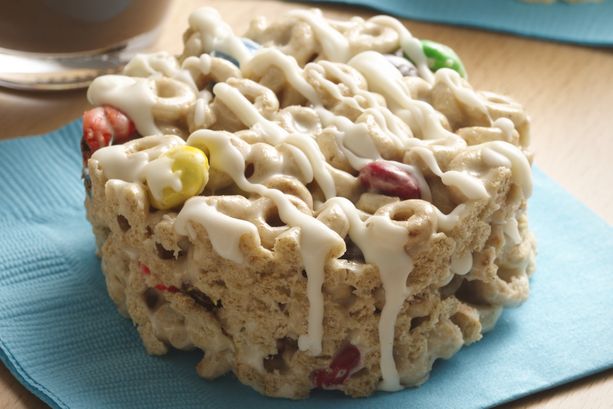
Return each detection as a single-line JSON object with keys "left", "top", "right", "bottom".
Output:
{"left": 147, "top": 145, "right": 209, "bottom": 210}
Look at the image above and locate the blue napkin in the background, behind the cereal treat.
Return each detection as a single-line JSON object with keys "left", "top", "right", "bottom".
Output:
{"left": 290, "top": 0, "right": 613, "bottom": 47}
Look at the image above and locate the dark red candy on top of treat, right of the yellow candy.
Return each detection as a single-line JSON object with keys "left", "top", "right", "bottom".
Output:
{"left": 359, "top": 161, "right": 421, "bottom": 200}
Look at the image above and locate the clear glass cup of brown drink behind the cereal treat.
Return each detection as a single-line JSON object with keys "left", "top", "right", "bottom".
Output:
{"left": 0, "top": 0, "right": 171, "bottom": 90}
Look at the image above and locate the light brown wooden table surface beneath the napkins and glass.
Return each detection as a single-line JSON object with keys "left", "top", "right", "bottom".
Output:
{"left": 0, "top": 0, "right": 613, "bottom": 409}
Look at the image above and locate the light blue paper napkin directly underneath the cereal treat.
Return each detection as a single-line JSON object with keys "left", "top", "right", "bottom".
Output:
{"left": 0, "top": 122, "right": 613, "bottom": 409}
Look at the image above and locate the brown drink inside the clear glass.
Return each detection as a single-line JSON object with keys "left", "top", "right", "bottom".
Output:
{"left": 0, "top": 0, "right": 170, "bottom": 53}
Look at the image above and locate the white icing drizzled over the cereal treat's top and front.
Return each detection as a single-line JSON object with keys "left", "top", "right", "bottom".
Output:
{"left": 83, "top": 7, "right": 532, "bottom": 390}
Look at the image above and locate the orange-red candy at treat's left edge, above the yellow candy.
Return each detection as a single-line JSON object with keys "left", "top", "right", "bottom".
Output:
{"left": 81, "top": 106, "right": 136, "bottom": 162}
